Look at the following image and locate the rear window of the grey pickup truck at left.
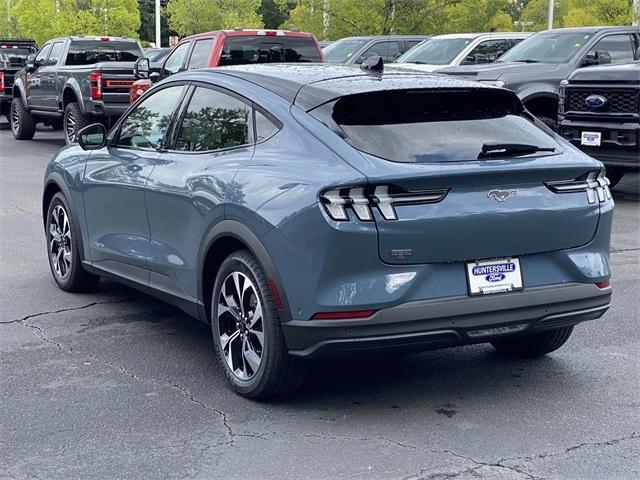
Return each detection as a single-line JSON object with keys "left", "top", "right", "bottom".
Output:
{"left": 65, "top": 40, "right": 142, "bottom": 65}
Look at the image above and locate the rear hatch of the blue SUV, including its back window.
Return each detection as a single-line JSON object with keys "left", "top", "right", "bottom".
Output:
{"left": 312, "top": 88, "right": 600, "bottom": 264}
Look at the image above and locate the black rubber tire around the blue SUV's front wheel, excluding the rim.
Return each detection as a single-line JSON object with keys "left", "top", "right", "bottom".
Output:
{"left": 45, "top": 192, "right": 100, "bottom": 292}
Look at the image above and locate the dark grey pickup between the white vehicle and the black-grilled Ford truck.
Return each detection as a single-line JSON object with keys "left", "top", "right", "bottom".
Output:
{"left": 437, "top": 26, "right": 640, "bottom": 129}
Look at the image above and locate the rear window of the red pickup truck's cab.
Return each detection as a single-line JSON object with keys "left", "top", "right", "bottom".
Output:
{"left": 220, "top": 35, "right": 322, "bottom": 65}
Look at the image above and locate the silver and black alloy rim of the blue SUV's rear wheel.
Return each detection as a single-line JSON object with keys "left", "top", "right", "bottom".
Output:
{"left": 217, "top": 272, "right": 264, "bottom": 380}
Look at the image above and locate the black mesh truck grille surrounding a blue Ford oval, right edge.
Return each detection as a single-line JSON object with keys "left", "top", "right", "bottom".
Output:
{"left": 565, "top": 88, "right": 640, "bottom": 113}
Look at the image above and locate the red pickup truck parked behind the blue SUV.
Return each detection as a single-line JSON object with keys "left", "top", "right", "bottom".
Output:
{"left": 129, "top": 29, "right": 324, "bottom": 103}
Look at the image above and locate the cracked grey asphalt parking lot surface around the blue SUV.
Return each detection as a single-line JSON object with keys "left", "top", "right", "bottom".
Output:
{"left": 0, "top": 124, "right": 640, "bottom": 480}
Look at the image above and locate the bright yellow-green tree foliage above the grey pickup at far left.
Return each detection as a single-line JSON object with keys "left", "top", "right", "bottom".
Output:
{"left": 0, "top": 0, "right": 140, "bottom": 44}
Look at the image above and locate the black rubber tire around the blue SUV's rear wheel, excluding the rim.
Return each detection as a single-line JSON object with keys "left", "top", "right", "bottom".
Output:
{"left": 211, "top": 250, "right": 305, "bottom": 399}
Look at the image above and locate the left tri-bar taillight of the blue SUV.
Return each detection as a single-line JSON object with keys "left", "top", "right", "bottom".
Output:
{"left": 320, "top": 185, "right": 449, "bottom": 222}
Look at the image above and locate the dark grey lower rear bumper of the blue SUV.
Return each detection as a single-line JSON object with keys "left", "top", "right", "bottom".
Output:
{"left": 283, "top": 283, "right": 612, "bottom": 358}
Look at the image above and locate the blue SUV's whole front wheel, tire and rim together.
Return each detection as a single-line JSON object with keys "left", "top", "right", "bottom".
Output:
{"left": 46, "top": 193, "right": 100, "bottom": 292}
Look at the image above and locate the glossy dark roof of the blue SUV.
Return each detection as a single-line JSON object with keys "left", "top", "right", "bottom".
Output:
{"left": 180, "top": 63, "right": 496, "bottom": 111}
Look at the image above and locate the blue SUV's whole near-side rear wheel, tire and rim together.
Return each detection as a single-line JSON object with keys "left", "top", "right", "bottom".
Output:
{"left": 211, "top": 250, "right": 304, "bottom": 399}
